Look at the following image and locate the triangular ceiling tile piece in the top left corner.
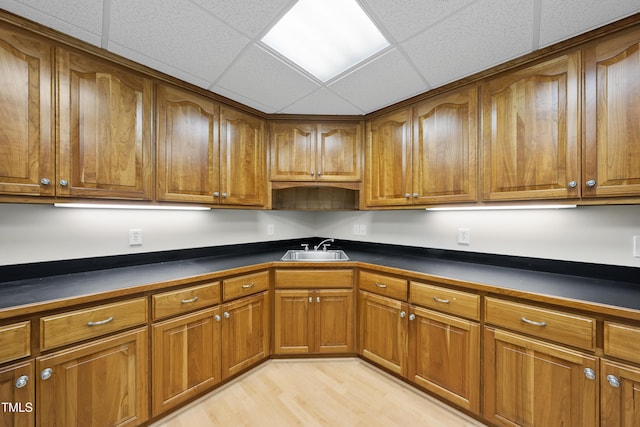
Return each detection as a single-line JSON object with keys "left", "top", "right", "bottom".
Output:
{"left": 0, "top": 0, "right": 102, "bottom": 46}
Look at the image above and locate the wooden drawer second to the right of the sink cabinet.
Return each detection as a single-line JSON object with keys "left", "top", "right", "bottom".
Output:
{"left": 409, "top": 282, "right": 480, "bottom": 320}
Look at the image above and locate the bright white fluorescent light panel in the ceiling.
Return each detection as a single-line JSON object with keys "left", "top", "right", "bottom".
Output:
{"left": 262, "top": 0, "right": 389, "bottom": 82}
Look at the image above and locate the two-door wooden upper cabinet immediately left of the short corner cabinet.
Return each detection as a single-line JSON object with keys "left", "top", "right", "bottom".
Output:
{"left": 157, "top": 85, "right": 267, "bottom": 206}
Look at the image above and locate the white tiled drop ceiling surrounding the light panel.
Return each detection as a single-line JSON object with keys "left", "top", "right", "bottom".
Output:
{"left": 0, "top": 0, "right": 640, "bottom": 115}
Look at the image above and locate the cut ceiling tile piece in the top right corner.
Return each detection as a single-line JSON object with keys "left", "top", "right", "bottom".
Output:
{"left": 540, "top": 0, "right": 640, "bottom": 47}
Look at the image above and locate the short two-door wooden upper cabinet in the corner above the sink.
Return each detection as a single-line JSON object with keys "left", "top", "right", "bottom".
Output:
{"left": 270, "top": 121, "right": 362, "bottom": 181}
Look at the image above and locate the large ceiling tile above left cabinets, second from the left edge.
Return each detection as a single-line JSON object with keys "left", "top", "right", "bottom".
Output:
{"left": 109, "top": 0, "right": 249, "bottom": 82}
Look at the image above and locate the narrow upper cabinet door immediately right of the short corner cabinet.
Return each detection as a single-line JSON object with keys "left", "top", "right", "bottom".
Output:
{"left": 365, "top": 108, "right": 413, "bottom": 207}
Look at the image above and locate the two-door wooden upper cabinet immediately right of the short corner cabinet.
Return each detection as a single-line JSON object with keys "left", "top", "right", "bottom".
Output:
{"left": 365, "top": 86, "right": 478, "bottom": 207}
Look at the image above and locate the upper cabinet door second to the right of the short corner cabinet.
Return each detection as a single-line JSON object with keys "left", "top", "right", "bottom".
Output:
{"left": 411, "top": 86, "right": 478, "bottom": 204}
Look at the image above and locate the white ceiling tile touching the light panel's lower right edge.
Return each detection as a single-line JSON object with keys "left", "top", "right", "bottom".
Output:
{"left": 329, "top": 49, "right": 428, "bottom": 113}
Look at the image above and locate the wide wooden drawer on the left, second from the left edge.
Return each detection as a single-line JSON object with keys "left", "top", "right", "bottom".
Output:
{"left": 40, "top": 297, "right": 147, "bottom": 350}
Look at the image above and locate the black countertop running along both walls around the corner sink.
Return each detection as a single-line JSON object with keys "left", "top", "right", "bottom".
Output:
{"left": 0, "top": 239, "right": 640, "bottom": 317}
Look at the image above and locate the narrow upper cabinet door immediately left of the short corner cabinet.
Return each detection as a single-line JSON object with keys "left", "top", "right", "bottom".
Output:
{"left": 219, "top": 107, "right": 267, "bottom": 206}
